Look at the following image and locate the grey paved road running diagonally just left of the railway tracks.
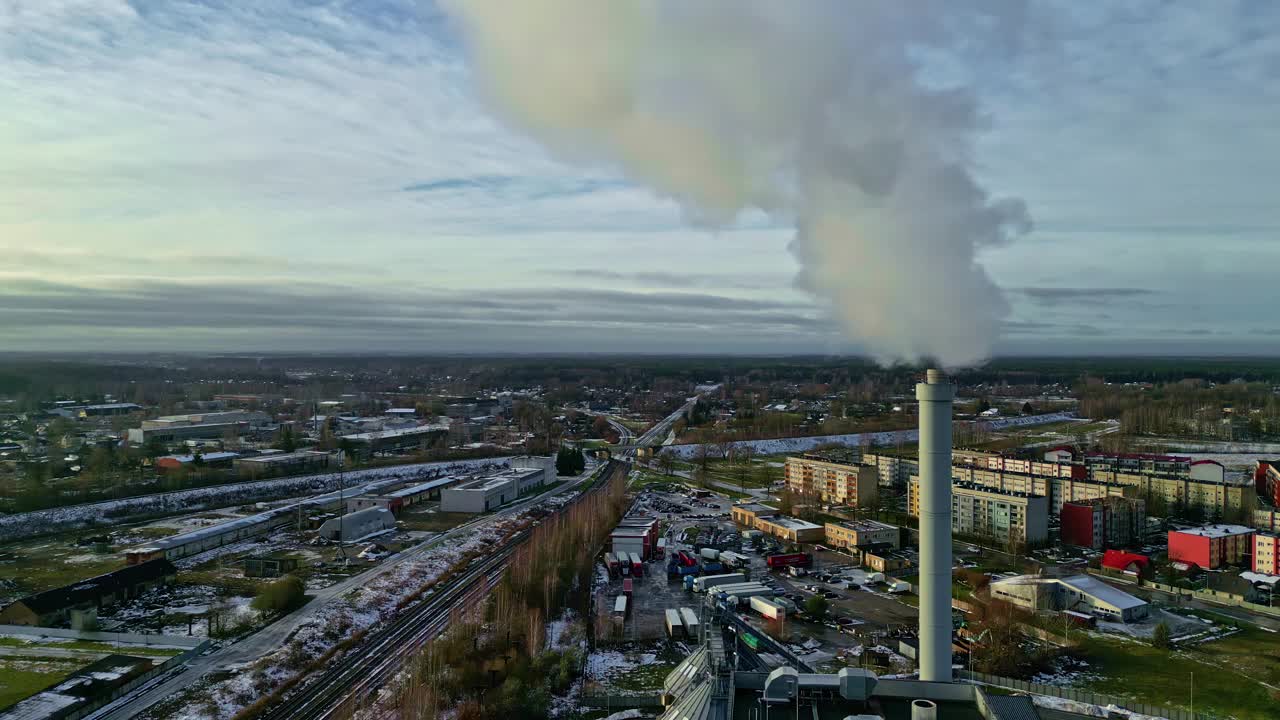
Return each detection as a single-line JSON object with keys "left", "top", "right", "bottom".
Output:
{"left": 92, "top": 458, "right": 595, "bottom": 720}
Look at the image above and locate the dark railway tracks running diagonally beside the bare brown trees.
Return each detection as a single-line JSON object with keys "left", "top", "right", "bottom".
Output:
{"left": 260, "top": 462, "right": 622, "bottom": 720}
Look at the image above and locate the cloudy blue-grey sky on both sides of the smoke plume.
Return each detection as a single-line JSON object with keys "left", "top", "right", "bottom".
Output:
{"left": 0, "top": 0, "right": 1280, "bottom": 355}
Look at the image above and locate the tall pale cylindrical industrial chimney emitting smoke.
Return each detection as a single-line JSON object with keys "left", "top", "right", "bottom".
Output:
{"left": 915, "top": 370, "right": 955, "bottom": 683}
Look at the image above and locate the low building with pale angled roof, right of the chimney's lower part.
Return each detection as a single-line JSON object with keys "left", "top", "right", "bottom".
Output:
{"left": 991, "top": 575, "right": 1149, "bottom": 623}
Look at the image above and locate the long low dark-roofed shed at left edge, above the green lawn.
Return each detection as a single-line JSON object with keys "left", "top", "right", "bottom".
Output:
{"left": 0, "top": 559, "right": 178, "bottom": 628}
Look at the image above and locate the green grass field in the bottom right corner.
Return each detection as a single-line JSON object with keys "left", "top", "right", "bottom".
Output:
{"left": 1080, "top": 629, "right": 1280, "bottom": 720}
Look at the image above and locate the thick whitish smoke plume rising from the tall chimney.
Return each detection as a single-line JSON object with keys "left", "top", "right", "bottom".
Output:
{"left": 443, "top": 0, "right": 1030, "bottom": 365}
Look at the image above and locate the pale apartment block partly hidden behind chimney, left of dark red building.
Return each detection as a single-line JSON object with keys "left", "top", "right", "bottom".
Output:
{"left": 908, "top": 478, "right": 1048, "bottom": 547}
